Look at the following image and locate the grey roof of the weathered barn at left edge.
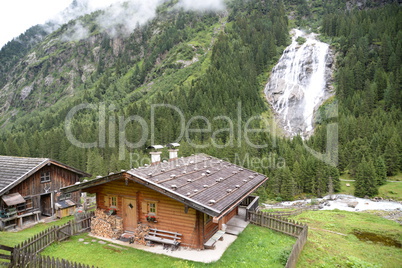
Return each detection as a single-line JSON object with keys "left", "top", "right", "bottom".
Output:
{"left": 0, "top": 156, "right": 90, "bottom": 195}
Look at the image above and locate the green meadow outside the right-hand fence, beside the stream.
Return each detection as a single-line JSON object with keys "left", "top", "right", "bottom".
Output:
{"left": 292, "top": 210, "right": 402, "bottom": 267}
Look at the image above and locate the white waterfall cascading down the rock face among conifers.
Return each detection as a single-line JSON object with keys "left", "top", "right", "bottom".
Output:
{"left": 265, "top": 29, "right": 333, "bottom": 137}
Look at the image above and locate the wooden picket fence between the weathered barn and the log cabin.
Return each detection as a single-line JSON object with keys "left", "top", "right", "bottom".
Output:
{"left": 10, "top": 211, "right": 94, "bottom": 268}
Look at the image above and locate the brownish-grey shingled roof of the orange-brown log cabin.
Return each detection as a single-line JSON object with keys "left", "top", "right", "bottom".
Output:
{"left": 64, "top": 154, "right": 268, "bottom": 216}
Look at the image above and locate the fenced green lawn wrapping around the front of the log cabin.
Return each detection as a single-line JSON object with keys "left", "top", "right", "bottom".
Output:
{"left": 42, "top": 224, "right": 296, "bottom": 267}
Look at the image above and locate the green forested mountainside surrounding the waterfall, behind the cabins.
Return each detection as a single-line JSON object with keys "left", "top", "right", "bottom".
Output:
{"left": 0, "top": 0, "right": 402, "bottom": 199}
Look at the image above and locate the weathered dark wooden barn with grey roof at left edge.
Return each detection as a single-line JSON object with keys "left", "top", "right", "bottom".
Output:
{"left": 0, "top": 156, "right": 90, "bottom": 230}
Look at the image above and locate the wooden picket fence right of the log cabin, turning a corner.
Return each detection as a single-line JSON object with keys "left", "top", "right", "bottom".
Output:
{"left": 249, "top": 211, "right": 308, "bottom": 268}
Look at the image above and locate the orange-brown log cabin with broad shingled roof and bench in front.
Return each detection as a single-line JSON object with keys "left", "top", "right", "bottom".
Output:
{"left": 61, "top": 153, "right": 267, "bottom": 249}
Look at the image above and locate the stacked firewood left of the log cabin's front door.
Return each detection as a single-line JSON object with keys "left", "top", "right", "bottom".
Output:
{"left": 91, "top": 209, "right": 123, "bottom": 239}
